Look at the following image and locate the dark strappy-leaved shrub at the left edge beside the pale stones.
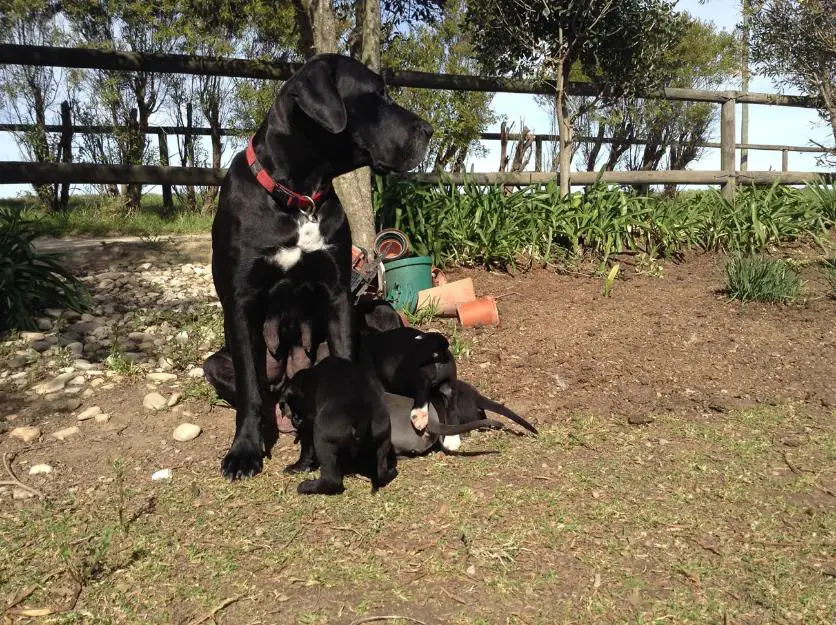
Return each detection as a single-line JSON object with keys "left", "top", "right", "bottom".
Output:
{"left": 0, "top": 208, "right": 88, "bottom": 330}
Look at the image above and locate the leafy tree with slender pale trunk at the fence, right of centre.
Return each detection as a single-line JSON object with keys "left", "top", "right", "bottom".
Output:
{"left": 468, "top": 0, "right": 682, "bottom": 194}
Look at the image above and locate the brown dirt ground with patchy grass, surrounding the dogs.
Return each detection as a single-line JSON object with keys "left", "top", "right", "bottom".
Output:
{"left": 0, "top": 236, "right": 836, "bottom": 625}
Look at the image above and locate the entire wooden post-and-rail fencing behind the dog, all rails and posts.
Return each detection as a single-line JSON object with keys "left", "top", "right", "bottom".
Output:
{"left": 0, "top": 44, "right": 833, "bottom": 198}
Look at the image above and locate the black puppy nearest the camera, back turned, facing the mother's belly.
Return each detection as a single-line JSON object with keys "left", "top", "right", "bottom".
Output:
{"left": 280, "top": 356, "right": 398, "bottom": 495}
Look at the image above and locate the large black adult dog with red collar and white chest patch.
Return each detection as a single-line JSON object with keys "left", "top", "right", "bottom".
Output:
{"left": 204, "top": 54, "right": 432, "bottom": 479}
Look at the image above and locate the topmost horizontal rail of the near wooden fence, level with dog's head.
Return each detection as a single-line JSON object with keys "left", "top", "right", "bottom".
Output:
{"left": 0, "top": 44, "right": 819, "bottom": 108}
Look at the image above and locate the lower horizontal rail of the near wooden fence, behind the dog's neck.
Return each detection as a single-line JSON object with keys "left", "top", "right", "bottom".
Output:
{"left": 0, "top": 161, "right": 836, "bottom": 186}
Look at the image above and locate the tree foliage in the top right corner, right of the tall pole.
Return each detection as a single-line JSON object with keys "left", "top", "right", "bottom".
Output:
{"left": 749, "top": 0, "right": 836, "bottom": 161}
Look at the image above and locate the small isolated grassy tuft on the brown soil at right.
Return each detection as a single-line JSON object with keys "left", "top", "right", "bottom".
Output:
{"left": 726, "top": 256, "right": 802, "bottom": 302}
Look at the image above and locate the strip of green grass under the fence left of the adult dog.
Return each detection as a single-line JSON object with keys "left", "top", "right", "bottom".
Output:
{"left": 0, "top": 194, "right": 212, "bottom": 237}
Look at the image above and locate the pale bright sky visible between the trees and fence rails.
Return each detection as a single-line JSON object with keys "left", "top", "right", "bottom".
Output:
{"left": 0, "top": 0, "right": 832, "bottom": 197}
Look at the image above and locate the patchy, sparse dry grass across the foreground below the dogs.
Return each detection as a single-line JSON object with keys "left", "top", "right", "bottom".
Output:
{"left": 0, "top": 405, "right": 836, "bottom": 625}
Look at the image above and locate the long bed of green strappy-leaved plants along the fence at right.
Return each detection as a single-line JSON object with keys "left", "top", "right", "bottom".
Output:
{"left": 374, "top": 178, "right": 836, "bottom": 266}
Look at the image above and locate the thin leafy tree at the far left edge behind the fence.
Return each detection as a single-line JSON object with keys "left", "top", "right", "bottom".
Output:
{"left": 0, "top": 0, "right": 69, "bottom": 210}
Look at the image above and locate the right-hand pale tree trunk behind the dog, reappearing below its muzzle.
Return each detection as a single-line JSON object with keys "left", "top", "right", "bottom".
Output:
{"left": 334, "top": 0, "right": 380, "bottom": 250}
